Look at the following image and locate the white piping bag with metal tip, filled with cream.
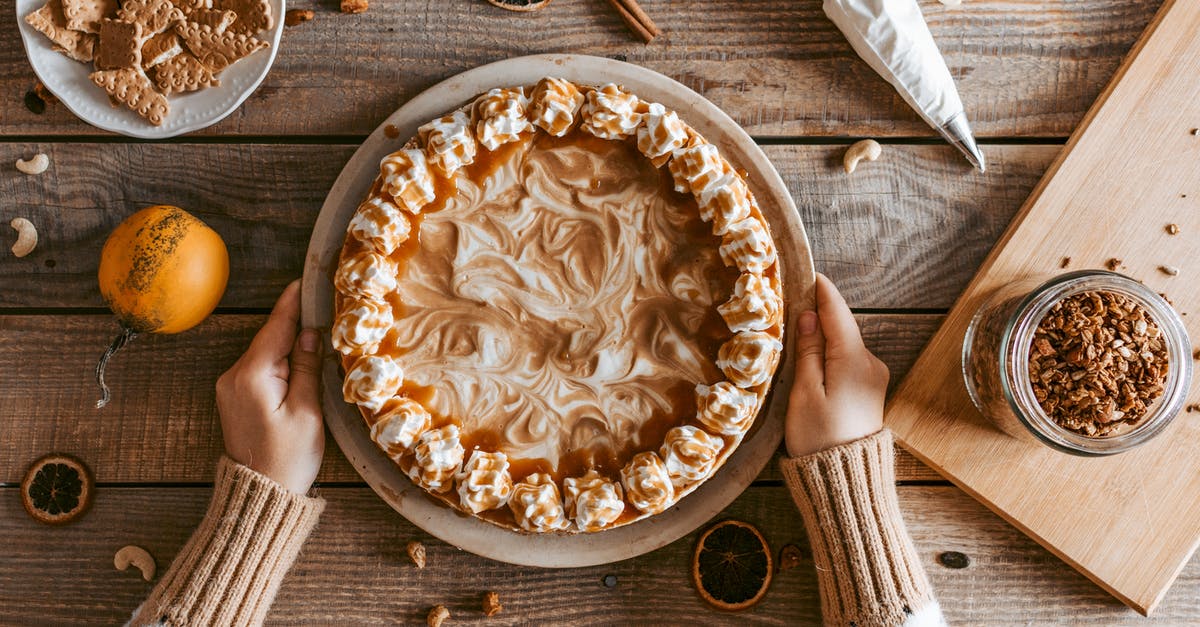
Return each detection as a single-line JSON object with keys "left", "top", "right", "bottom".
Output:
{"left": 824, "top": 0, "right": 986, "bottom": 172}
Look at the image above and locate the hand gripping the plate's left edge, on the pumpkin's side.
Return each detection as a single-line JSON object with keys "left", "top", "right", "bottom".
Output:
{"left": 217, "top": 281, "right": 325, "bottom": 494}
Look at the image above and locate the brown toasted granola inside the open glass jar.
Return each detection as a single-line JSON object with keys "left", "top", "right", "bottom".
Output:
{"left": 1030, "top": 291, "right": 1169, "bottom": 437}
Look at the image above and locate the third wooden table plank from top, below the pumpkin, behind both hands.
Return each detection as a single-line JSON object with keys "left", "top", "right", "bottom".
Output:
{"left": 0, "top": 315, "right": 941, "bottom": 484}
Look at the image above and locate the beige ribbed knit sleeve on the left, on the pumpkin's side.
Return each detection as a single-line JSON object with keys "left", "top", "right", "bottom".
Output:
{"left": 130, "top": 458, "right": 325, "bottom": 626}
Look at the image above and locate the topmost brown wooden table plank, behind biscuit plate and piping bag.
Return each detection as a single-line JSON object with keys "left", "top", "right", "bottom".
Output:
{"left": 0, "top": 0, "right": 1160, "bottom": 136}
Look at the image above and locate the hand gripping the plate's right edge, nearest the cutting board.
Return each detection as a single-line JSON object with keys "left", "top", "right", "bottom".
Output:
{"left": 785, "top": 274, "right": 888, "bottom": 456}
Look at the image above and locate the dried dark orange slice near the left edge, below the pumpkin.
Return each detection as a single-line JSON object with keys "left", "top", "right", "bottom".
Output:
{"left": 20, "top": 453, "right": 96, "bottom": 525}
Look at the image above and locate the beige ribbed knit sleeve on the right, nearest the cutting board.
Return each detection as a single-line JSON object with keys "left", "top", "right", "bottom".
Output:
{"left": 781, "top": 430, "right": 944, "bottom": 627}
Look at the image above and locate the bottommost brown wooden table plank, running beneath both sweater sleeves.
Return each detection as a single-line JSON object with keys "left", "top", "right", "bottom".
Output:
{"left": 0, "top": 486, "right": 1200, "bottom": 626}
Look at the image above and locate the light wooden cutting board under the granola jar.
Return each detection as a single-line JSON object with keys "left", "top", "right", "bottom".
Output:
{"left": 886, "top": 0, "right": 1200, "bottom": 615}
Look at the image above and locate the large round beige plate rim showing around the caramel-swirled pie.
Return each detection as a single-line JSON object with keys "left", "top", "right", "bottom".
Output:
{"left": 300, "top": 54, "right": 815, "bottom": 567}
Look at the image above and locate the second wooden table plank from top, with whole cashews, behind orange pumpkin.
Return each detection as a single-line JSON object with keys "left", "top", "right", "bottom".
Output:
{"left": 0, "top": 143, "right": 1051, "bottom": 310}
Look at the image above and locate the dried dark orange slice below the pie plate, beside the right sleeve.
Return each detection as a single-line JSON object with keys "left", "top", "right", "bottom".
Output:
{"left": 691, "top": 520, "right": 772, "bottom": 611}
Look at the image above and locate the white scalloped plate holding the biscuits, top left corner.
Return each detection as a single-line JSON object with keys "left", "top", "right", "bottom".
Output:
{"left": 17, "top": 0, "right": 284, "bottom": 139}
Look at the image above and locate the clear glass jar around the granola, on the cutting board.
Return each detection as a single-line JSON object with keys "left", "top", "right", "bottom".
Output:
{"left": 962, "top": 270, "right": 1192, "bottom": 456}
